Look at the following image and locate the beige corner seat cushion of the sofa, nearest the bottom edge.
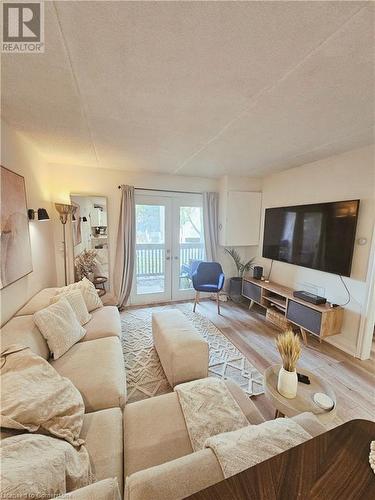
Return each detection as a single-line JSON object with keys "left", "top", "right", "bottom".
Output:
{"left": 80, "top": 408, "right": 124, "bottom": 492}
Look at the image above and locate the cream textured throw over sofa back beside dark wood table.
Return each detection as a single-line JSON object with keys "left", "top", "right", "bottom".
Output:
{"left": 205, "top": 418, "right": 311, "bottom": 478}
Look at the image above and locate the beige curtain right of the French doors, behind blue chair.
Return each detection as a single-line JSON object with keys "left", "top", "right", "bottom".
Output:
{"left": 203, "top": 193, "right": 219, "bottom": 262}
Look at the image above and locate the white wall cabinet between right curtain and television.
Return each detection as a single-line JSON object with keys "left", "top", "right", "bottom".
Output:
{"left": 219, "top": 190, "right": 262, "bottom": 247}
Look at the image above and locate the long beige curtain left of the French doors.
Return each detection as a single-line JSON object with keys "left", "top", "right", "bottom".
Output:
{"left": 114, "top": 185, "right": 135, "bottom": 309}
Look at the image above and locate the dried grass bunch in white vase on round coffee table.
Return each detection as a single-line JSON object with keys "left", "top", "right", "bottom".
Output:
{"left": 276, "top": 330, "right": 301, "bottom": 399}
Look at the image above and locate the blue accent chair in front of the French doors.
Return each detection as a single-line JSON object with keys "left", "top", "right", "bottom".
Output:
{"left": 191, "top": 262, "right": 225, "bottom": 314}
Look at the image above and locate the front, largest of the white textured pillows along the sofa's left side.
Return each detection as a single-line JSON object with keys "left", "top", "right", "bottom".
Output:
{"left": 33, "top": 297, "right": 86, "bottom": 359}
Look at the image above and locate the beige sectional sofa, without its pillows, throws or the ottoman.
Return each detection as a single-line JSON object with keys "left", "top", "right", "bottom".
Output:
{"left": 0, "top": 288, "right": 325, "bottom": 500}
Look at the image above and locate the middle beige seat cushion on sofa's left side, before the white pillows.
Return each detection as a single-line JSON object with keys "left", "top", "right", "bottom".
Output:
{"left": 51, "top": 337, "right": 126, "bottom": 412}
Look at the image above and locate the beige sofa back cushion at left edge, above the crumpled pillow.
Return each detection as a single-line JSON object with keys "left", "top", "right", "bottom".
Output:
{"left": 0, "top": 315, "right": 50, "bottom": 359}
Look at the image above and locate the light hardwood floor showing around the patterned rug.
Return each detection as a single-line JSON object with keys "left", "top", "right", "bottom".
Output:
{"left": 137, "top": 300, "right": 375, "bottom": 421}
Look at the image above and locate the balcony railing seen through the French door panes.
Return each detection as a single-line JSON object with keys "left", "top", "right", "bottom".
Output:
{"left": 136, "top": 243, "right": 204, "bottom": 277}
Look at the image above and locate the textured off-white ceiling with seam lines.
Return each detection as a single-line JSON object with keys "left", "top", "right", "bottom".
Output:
{"left": 2, "top": 1, "right": 375, "bottom": 177}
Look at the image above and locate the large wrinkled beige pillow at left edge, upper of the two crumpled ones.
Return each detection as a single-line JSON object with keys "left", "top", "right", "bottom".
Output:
{"left": 0, "top": 344, "right": 85, "bottom": 446}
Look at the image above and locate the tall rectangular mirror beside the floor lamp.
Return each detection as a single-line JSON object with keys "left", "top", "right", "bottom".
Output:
{"left": 70, "top": 194, "right": 109, "bottom": 296}
